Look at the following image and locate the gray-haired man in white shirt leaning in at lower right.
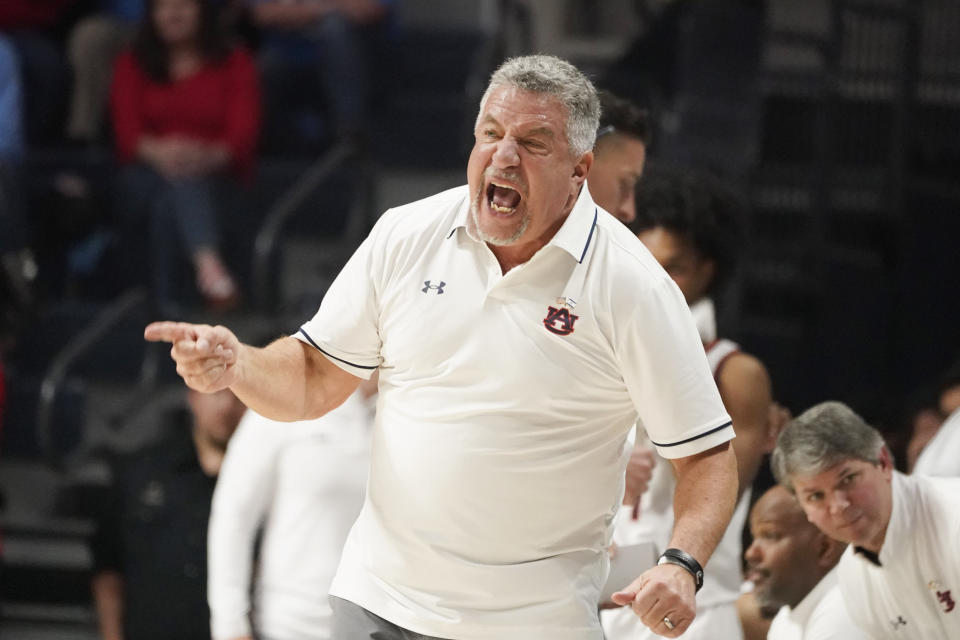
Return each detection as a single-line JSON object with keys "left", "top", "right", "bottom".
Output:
{"left": 771, "top": 402, "right": 960, "bottom": 640}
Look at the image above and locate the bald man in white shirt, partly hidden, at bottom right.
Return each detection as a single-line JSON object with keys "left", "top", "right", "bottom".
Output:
{"left": 744, "top": 485, "right": 866, "bottom": 640}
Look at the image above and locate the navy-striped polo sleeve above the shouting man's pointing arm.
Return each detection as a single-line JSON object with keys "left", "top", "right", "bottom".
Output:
{"left": 294, "top": 212, "right": 392, "bottom": 380}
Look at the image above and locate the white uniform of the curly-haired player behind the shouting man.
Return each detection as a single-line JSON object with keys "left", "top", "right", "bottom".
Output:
{"left": 600, "top": 336, "right": 750, "bottom": 640}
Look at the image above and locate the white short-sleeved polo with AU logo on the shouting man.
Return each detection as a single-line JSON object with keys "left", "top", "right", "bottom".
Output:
{"left": 298, "top": 182, "right": 733, "bottom": 640}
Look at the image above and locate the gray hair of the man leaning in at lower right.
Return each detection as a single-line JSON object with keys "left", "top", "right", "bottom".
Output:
{"left": 770, "top": 401, "right": 884, "bottom": 492}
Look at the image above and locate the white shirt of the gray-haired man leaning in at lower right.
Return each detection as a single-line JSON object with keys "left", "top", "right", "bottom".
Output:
{"left": 838, "top": 472, "right": 960, "bottom": 640}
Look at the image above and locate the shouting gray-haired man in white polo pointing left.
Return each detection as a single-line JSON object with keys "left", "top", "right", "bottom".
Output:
{"left": 145, "top": 56, "right": 737, "bottom": 640}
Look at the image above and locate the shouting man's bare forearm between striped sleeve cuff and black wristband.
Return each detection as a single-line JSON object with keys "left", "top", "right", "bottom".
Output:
{"left": 670, "top": 443, "right": 738, "bottom": 566}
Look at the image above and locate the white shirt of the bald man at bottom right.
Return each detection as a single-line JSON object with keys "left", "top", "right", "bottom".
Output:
{"left": 767, "top": 560, "right": 869, "bottom": 640}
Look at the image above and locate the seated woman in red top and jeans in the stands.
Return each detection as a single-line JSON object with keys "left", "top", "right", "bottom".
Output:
{"left": 110, "top": 0, "right": 260, "bottom": 307}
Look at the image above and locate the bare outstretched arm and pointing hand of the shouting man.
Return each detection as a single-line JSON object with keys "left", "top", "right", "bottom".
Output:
{"left": 144, "top": 322, "right": 361, "bottom": 422}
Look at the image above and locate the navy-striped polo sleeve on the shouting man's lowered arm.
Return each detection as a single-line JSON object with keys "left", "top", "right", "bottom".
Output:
{"left": 616, "top": 276, "right": 734, "bottom": 459}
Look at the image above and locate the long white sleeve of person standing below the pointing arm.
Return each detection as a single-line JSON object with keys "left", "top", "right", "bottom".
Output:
{"left": 207, "top": 411, "right": 283, "bottom": 640}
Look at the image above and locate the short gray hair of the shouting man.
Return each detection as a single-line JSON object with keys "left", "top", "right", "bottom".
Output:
{"left": 477, "top": 55, "right": 600, "bottom": 157}
